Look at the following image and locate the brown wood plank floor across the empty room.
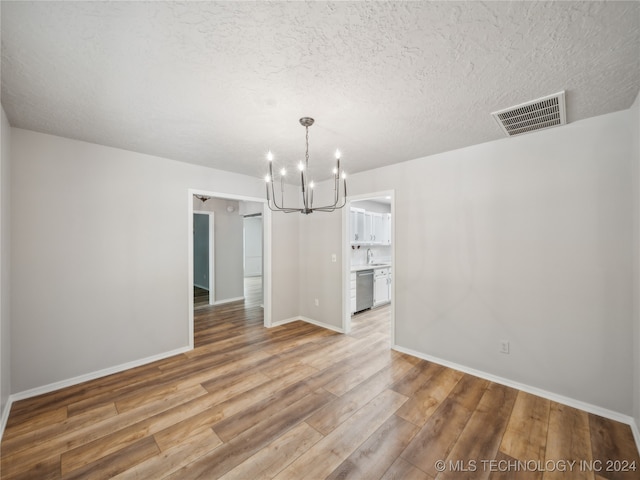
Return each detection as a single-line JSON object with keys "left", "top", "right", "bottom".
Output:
{"left": 1, "top": 294, "right": 640, "bottom": 480}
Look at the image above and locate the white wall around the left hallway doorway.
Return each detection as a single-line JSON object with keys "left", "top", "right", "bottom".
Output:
{"left": 8, "top": 129, "right": 297, "bottom": 393}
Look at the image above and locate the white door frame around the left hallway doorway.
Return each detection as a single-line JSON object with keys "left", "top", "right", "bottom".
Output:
{"left": 187, "top": 188, "right": 272, "bottom": 349}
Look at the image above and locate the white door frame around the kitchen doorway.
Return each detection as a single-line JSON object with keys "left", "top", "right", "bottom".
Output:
{"left": 342, "top": 190, "right": 398, "bottom": 345}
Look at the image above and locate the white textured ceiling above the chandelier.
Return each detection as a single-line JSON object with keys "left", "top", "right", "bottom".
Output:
{"left": 1, "top": 1, "right": 640, "bottom": 181}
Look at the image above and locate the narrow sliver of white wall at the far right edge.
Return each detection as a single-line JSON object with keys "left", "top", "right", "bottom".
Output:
{"left": 629, "top": 94, "right": 640, "bottom": 428}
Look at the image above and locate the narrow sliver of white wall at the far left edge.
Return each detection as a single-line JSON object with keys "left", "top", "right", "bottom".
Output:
{"left": 0, "top": 109, "right": 11, "bottom": 420}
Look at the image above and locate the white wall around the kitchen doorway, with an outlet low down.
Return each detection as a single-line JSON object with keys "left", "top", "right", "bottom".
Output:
{"left": 301, "top": 112, "right": 633, "bottom": 415}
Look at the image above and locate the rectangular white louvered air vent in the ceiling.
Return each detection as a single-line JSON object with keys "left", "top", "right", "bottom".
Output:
{"left": 491, "top": 90, "right": 567, "bottom": 137}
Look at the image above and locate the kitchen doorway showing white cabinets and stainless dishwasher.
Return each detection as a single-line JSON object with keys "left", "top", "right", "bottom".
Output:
{"left": 342, "top": 190, "right": 396, "bottom": 346}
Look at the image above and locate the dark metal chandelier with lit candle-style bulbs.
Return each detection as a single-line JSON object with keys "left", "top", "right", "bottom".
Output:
{"left": 265, "top": 117, "right": 347, "bottom": 215}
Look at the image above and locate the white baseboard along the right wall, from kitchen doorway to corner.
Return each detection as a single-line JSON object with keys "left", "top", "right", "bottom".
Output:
{"left": 392, "top": 345, "right": 640, "bottom": 451}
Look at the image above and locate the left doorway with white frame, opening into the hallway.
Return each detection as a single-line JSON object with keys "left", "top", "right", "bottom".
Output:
{"left": 189, "top": 191, "right": 271, "bottom": 346}
